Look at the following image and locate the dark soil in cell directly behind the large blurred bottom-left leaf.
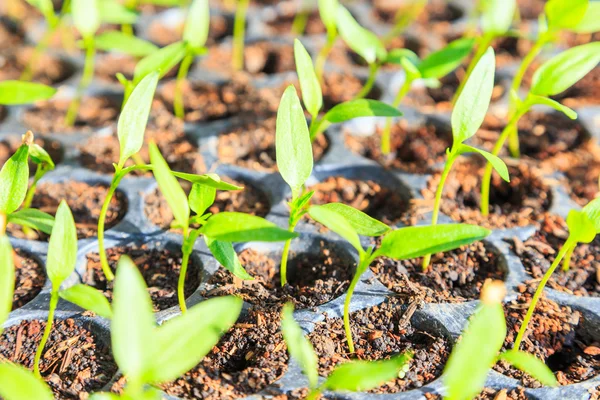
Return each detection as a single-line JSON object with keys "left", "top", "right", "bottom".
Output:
{"left": 82, "top": 244, "right": 201, "bottom": 311}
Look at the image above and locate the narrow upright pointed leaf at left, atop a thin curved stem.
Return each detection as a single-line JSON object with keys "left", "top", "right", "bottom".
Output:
{"left": 46, "top": 200, "right": 77, "bottom": 291}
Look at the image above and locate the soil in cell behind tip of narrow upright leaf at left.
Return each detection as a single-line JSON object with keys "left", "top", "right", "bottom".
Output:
{"left": 8, "top": 181, "right": 127, "bottom": 240}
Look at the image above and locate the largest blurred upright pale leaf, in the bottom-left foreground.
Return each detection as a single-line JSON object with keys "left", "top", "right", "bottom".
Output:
{"left": 110, "top": 255, "right": 155, "bottom": 382}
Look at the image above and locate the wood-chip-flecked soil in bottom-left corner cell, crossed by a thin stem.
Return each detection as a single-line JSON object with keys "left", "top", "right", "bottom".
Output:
{"left": 0, "top": 319, "right": 117, "bottom": 399}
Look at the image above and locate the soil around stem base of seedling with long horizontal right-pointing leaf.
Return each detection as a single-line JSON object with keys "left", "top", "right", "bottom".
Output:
{"left": 309, "top": 298, "right": 451, "bottom": 393}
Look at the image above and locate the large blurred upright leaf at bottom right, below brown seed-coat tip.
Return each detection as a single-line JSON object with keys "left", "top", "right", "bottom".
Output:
{"left": 443, "top": 303, "right": 506, "bottom": 400}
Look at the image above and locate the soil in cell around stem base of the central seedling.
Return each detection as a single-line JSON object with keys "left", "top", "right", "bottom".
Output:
{"left": 204, "top": 242, "right": 355, "bottom": 308}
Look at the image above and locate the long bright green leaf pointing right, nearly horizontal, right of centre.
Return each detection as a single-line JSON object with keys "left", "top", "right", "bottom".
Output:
{"left": 376, "top": 224, "right": 492, "bottom": 260}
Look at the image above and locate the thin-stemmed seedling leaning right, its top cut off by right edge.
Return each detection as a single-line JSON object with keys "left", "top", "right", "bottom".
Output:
{"left": 513, "top": 199, "right": 600, "bottom": 351}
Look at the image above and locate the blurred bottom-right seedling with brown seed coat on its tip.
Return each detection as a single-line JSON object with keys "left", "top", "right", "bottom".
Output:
{"left": 443, "top": 281, "right": 558, "bottom": 400}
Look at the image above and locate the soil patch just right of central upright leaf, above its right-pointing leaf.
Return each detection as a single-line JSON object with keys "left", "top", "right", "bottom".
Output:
{"left": 309, "top": 176, "right": 409, "bottom": 224}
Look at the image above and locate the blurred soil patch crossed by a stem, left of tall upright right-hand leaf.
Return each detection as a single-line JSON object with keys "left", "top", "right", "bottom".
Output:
{"left": 345, "top": 120, "right": 452, "bottom": 173}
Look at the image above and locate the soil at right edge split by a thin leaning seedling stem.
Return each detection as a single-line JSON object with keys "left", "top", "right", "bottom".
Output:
{"left": 511, "top": 215, "right": 600, "bottom": 297}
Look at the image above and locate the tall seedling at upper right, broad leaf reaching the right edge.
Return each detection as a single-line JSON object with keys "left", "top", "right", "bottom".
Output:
{"left": 481, "top": 41, "right": 600, "bottom": 215}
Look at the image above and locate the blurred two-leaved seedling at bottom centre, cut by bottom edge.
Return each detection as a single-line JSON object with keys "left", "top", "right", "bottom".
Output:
{"left": 281, "top": 303, "right": 413, "bottom": 400}
